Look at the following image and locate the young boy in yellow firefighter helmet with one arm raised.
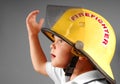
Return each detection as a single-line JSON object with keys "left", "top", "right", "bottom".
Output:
{"left": 26, "top": 6, "right": 115, "bottom": 84}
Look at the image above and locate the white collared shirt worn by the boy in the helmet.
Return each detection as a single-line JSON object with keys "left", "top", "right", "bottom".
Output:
{"left": 46, "top": 62, "right": 108, "bottom": 84}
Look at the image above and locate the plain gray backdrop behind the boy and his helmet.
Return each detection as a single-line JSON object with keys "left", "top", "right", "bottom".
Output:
{"left": 0, "top": 0, "right": 120, "bottom": 84}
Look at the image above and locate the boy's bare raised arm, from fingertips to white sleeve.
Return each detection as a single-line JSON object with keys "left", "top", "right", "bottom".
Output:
{"left": 26, "top": 10, "right": 47, "bottom": 75}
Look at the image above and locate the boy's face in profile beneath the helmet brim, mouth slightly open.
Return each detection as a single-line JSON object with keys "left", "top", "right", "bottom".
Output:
{"left": 50, "top": 36, "right": 72, "bottom": 68}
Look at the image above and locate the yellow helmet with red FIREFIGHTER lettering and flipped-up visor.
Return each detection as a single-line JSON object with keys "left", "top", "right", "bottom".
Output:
{"left": 42, "top": 5, "right": 116, "bottom": 84}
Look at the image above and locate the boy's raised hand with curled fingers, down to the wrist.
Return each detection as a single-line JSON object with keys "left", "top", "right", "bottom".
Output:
{"left": 26, "top": 10, "right": 44, "bottom": 35}
